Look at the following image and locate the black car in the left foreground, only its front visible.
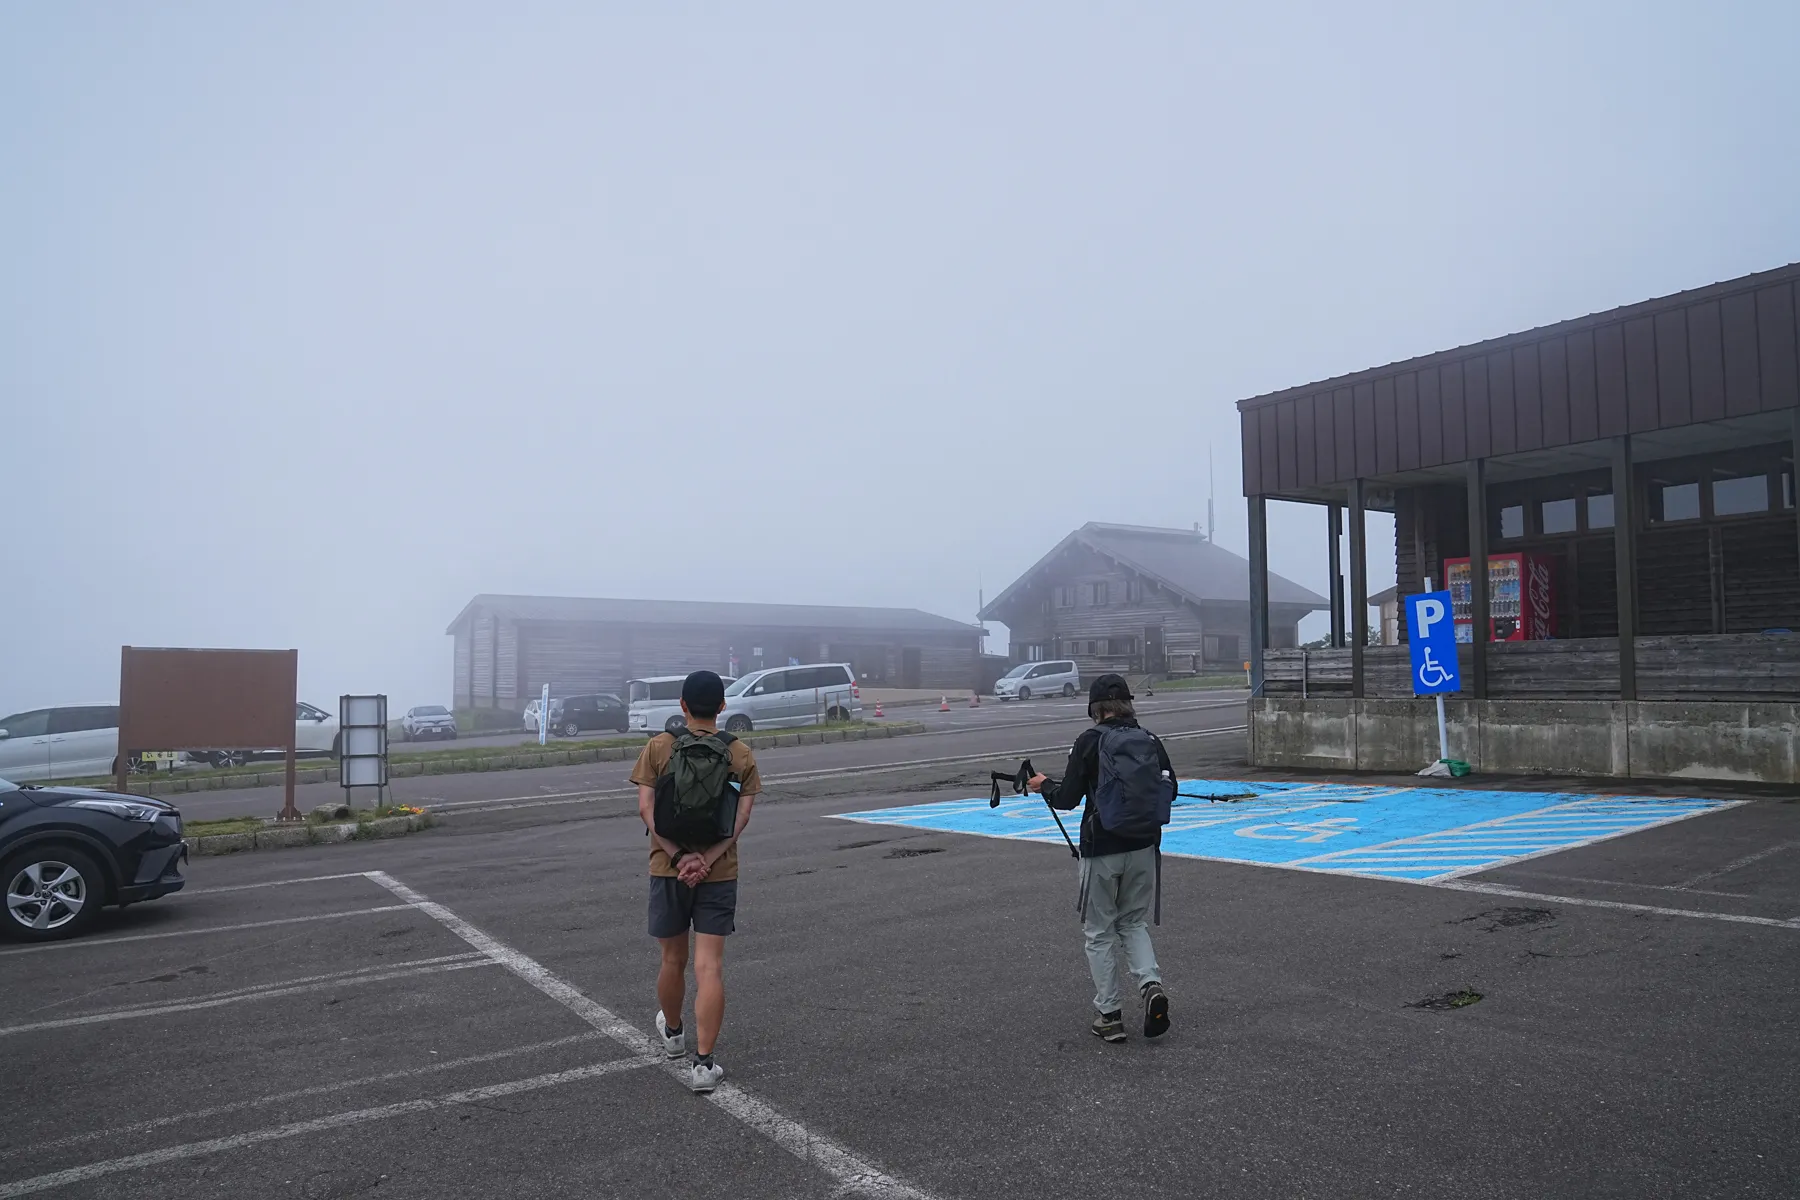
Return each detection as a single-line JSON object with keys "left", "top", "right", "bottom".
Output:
{"left": 0, "top": 779, "right": 187, "bottom": 941}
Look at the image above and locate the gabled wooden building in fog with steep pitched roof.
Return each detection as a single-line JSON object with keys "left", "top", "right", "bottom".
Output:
{"left": 981, "top": 522, "right": 1327, "bottom": 675}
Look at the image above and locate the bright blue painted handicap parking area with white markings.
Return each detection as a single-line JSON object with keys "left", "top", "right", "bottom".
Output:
{"left": 841, "top": 779, "right": 1741, "bottom": 883}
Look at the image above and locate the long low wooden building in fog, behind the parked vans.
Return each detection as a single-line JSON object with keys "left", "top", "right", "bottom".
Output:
{"left": 446, "top": 596, "right": 981, "bottom": 709}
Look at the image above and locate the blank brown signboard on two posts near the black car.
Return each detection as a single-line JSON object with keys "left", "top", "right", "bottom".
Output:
{"left": 115, "top": 646, "right": 301, "bottom": 820}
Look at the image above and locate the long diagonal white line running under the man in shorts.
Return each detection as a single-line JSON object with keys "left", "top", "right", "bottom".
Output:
{"left": 363, "top": 871, "right": 934, "bottom": 1200}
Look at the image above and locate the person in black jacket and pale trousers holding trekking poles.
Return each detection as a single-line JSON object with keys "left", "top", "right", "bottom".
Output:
{"left": 1028, "top": 675, "right": 1175, "bottom": 1042}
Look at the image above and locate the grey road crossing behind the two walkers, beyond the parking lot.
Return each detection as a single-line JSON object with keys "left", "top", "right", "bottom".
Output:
{"left": 166, "top": 693, "right": 1244, "bottom": 820}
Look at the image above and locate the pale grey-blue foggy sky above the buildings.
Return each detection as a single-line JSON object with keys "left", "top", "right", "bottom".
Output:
{"left": 0, "top": 2, "right": 1800, "bottom": 712}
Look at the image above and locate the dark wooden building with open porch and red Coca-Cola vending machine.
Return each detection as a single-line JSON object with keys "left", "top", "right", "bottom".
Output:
{"left": 1238, "top": 266, "right": 1800, "bottom": 781}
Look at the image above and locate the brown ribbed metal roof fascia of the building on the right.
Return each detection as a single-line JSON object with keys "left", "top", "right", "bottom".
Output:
{"left": 1238, "top": 263, "right": 1800, "bottom": 497}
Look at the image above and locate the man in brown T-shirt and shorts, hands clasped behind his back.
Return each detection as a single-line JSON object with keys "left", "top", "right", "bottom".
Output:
{"left": 632, "top": 671, "right": 763, "bottom": 1092}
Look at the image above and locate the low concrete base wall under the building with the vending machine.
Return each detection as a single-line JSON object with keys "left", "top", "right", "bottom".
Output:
{"left": 1249, "top": 696, "right": 1800, "bottom": 783}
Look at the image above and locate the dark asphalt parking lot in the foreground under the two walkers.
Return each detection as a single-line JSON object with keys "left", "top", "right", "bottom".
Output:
{"left": 0, "top": 755, "right": 1800, "bottom": 1200}
